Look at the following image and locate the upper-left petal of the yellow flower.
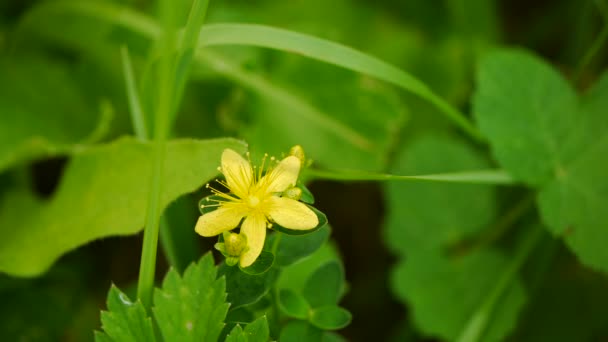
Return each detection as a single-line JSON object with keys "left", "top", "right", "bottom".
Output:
{"left": 222, "top": 148, "right": 253, "bottom": 198}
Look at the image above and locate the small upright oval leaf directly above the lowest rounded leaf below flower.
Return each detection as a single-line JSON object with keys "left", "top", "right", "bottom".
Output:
{"left": 302, "top": 261, "right": 344, "bottom": 309}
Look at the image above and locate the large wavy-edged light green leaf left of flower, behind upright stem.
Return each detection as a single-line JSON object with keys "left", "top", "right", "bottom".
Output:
{"left": 0, "top": 139, "right": 244, "bottom": 276}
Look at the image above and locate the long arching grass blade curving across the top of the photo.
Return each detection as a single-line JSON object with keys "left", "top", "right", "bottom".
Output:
{"left": 27, "top": 1, "right": 483, "bottom": 141}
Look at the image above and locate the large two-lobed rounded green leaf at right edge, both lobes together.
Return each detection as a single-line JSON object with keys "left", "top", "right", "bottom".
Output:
{"left": 475, "top": 51, "right": 608, "bottom": 272}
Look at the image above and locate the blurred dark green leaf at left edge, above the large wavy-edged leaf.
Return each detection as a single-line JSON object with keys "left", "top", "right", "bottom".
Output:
{"left": 0, "top": 57, "right": 112, "bottom": 171}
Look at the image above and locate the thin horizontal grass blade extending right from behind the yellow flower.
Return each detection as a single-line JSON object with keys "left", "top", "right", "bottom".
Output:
{"left": 303, "top": 169, "right": 515, "bottom": 185}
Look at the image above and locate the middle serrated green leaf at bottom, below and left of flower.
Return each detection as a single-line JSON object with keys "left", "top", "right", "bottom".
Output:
{"left": 153, "top": 253, "right": 229, "bottom": 341}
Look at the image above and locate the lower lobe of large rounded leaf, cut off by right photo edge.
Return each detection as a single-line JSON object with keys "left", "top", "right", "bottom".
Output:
{"left": 538, "top": 73, "right": 608, "bottom": 272}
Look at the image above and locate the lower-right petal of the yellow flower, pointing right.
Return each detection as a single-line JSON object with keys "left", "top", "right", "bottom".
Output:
{"left": 268, "top": 196, "right": 319, "bottom": 230}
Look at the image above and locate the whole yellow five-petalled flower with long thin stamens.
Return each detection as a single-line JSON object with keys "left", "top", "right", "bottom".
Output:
{"left": 194, "top": 149, "right": 319, "bottom": 267}
